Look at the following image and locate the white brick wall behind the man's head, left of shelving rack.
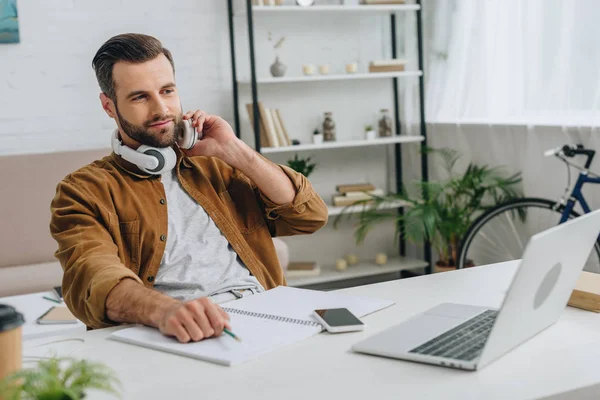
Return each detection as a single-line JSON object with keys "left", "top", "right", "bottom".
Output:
{"left": 0, "top": 0, "right": 232, "bottom": 155}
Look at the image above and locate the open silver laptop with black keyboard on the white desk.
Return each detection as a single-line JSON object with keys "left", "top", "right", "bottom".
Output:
{"left": 352, "top": 210, "right": 600, "bottom": 371}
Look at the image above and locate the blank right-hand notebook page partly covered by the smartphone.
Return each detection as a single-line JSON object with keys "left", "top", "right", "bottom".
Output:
{"left": 222, "top": 286, "right": 394, "bottom": 321}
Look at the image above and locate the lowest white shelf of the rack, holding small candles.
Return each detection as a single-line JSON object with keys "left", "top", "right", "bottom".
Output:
{"left": 287, "top": 257, "right": 428, "bottom": 286}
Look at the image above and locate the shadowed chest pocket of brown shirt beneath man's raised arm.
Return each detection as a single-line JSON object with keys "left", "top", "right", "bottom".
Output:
{"left": 219, "top": 179, "right": 265, "bottom": 235}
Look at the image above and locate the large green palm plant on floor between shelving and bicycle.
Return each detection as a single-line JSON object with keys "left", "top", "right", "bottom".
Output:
{"left": 335, "top": 149, "right": 522, "bottom": 270}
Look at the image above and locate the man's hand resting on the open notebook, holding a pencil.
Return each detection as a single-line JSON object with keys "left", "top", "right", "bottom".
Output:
{"left": 158, "top": 297, "right": 231, "bottom": 343}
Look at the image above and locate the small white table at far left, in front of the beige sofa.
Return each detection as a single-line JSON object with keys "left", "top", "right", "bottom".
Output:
{"left": 0, "top": 292, "right": 86, "bottom": 340}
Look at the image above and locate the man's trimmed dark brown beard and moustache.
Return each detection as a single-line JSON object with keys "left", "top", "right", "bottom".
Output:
{"left": 115, "top": 106, "right": 185, "bottom": 147}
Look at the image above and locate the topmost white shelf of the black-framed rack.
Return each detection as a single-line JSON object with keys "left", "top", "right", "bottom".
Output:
{"left": 236, "top": 4, "right": 421, "bottom": 15}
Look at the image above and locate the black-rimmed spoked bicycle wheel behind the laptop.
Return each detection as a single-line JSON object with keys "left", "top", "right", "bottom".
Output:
{"left": 458, "top": 198, "right": 600, "bottom": 273}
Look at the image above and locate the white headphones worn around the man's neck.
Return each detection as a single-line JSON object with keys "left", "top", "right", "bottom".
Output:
{"left": 111, "top": 120, "right": 198, "bottom": 175}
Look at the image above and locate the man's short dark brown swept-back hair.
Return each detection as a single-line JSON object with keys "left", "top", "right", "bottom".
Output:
{"left": 92, "top": 33, "right": 175, "bottom": 102}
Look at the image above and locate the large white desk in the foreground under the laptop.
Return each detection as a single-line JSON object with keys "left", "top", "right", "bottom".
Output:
{"left": 25, "top": 262, "right": 600, "bottom": 400}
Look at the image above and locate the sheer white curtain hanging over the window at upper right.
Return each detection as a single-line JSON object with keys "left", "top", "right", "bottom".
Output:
{"left": 425, "top": 0, "right": 600, "bottom": 126}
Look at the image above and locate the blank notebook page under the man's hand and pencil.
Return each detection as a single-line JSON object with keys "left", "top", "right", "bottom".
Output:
{"left": 110, "top": 313, "right": 321, "bottom": 365}
